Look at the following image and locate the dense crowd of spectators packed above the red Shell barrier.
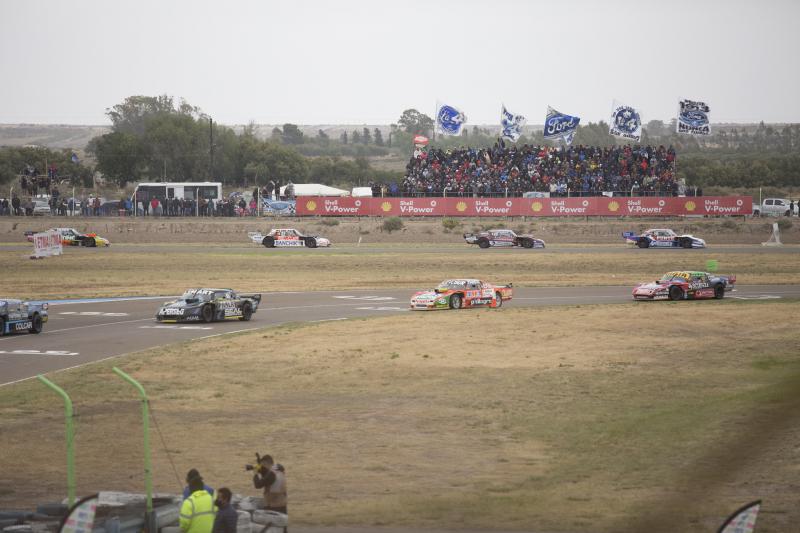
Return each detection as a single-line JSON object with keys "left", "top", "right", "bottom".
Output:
{"left": 400, "top": 142, "right": 680, "bottom": 196}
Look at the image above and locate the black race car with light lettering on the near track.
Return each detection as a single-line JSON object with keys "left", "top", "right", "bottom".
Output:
{"left": 156, "top": 288, "right": 261, "bottom": 322}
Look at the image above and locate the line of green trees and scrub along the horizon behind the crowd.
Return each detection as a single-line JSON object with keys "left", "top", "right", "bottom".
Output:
{"left": 0, "top": 95, "right": 800, "bottom": 188}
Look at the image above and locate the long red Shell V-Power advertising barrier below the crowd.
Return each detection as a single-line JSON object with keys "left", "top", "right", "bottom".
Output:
{"left": 296, "top": 196, "right": 753, "bottom": 217}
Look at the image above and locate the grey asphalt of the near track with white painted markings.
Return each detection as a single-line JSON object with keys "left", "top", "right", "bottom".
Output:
{"left": 0, "top": 285, "right": 800, "bottom": 386}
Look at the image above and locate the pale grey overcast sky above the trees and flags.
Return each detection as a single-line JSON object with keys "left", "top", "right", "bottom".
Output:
{"left": 0, "top": 0, "right": 800, "bottom": 124}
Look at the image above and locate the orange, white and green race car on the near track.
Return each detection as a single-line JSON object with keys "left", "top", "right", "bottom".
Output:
{"left": 410, "top": 279, "right": 514, "bottom": 311}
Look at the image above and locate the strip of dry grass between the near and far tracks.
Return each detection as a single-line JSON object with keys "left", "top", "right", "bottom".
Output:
{"left": 0, "top": 245, "right": 800, "bottom": 298}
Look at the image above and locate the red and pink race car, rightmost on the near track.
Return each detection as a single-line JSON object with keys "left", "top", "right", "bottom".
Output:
{"left": 633, "top": 270, "right": 736, "bottom": 300}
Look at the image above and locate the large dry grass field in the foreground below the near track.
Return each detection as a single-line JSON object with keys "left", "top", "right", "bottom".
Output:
{"left": 0, "top": 301, "right": 800, "bottom": 532}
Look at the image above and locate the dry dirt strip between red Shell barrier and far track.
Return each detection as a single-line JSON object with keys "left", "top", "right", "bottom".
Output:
{"left": 0, "top": 217, "right": 800, "bottom": 245}
